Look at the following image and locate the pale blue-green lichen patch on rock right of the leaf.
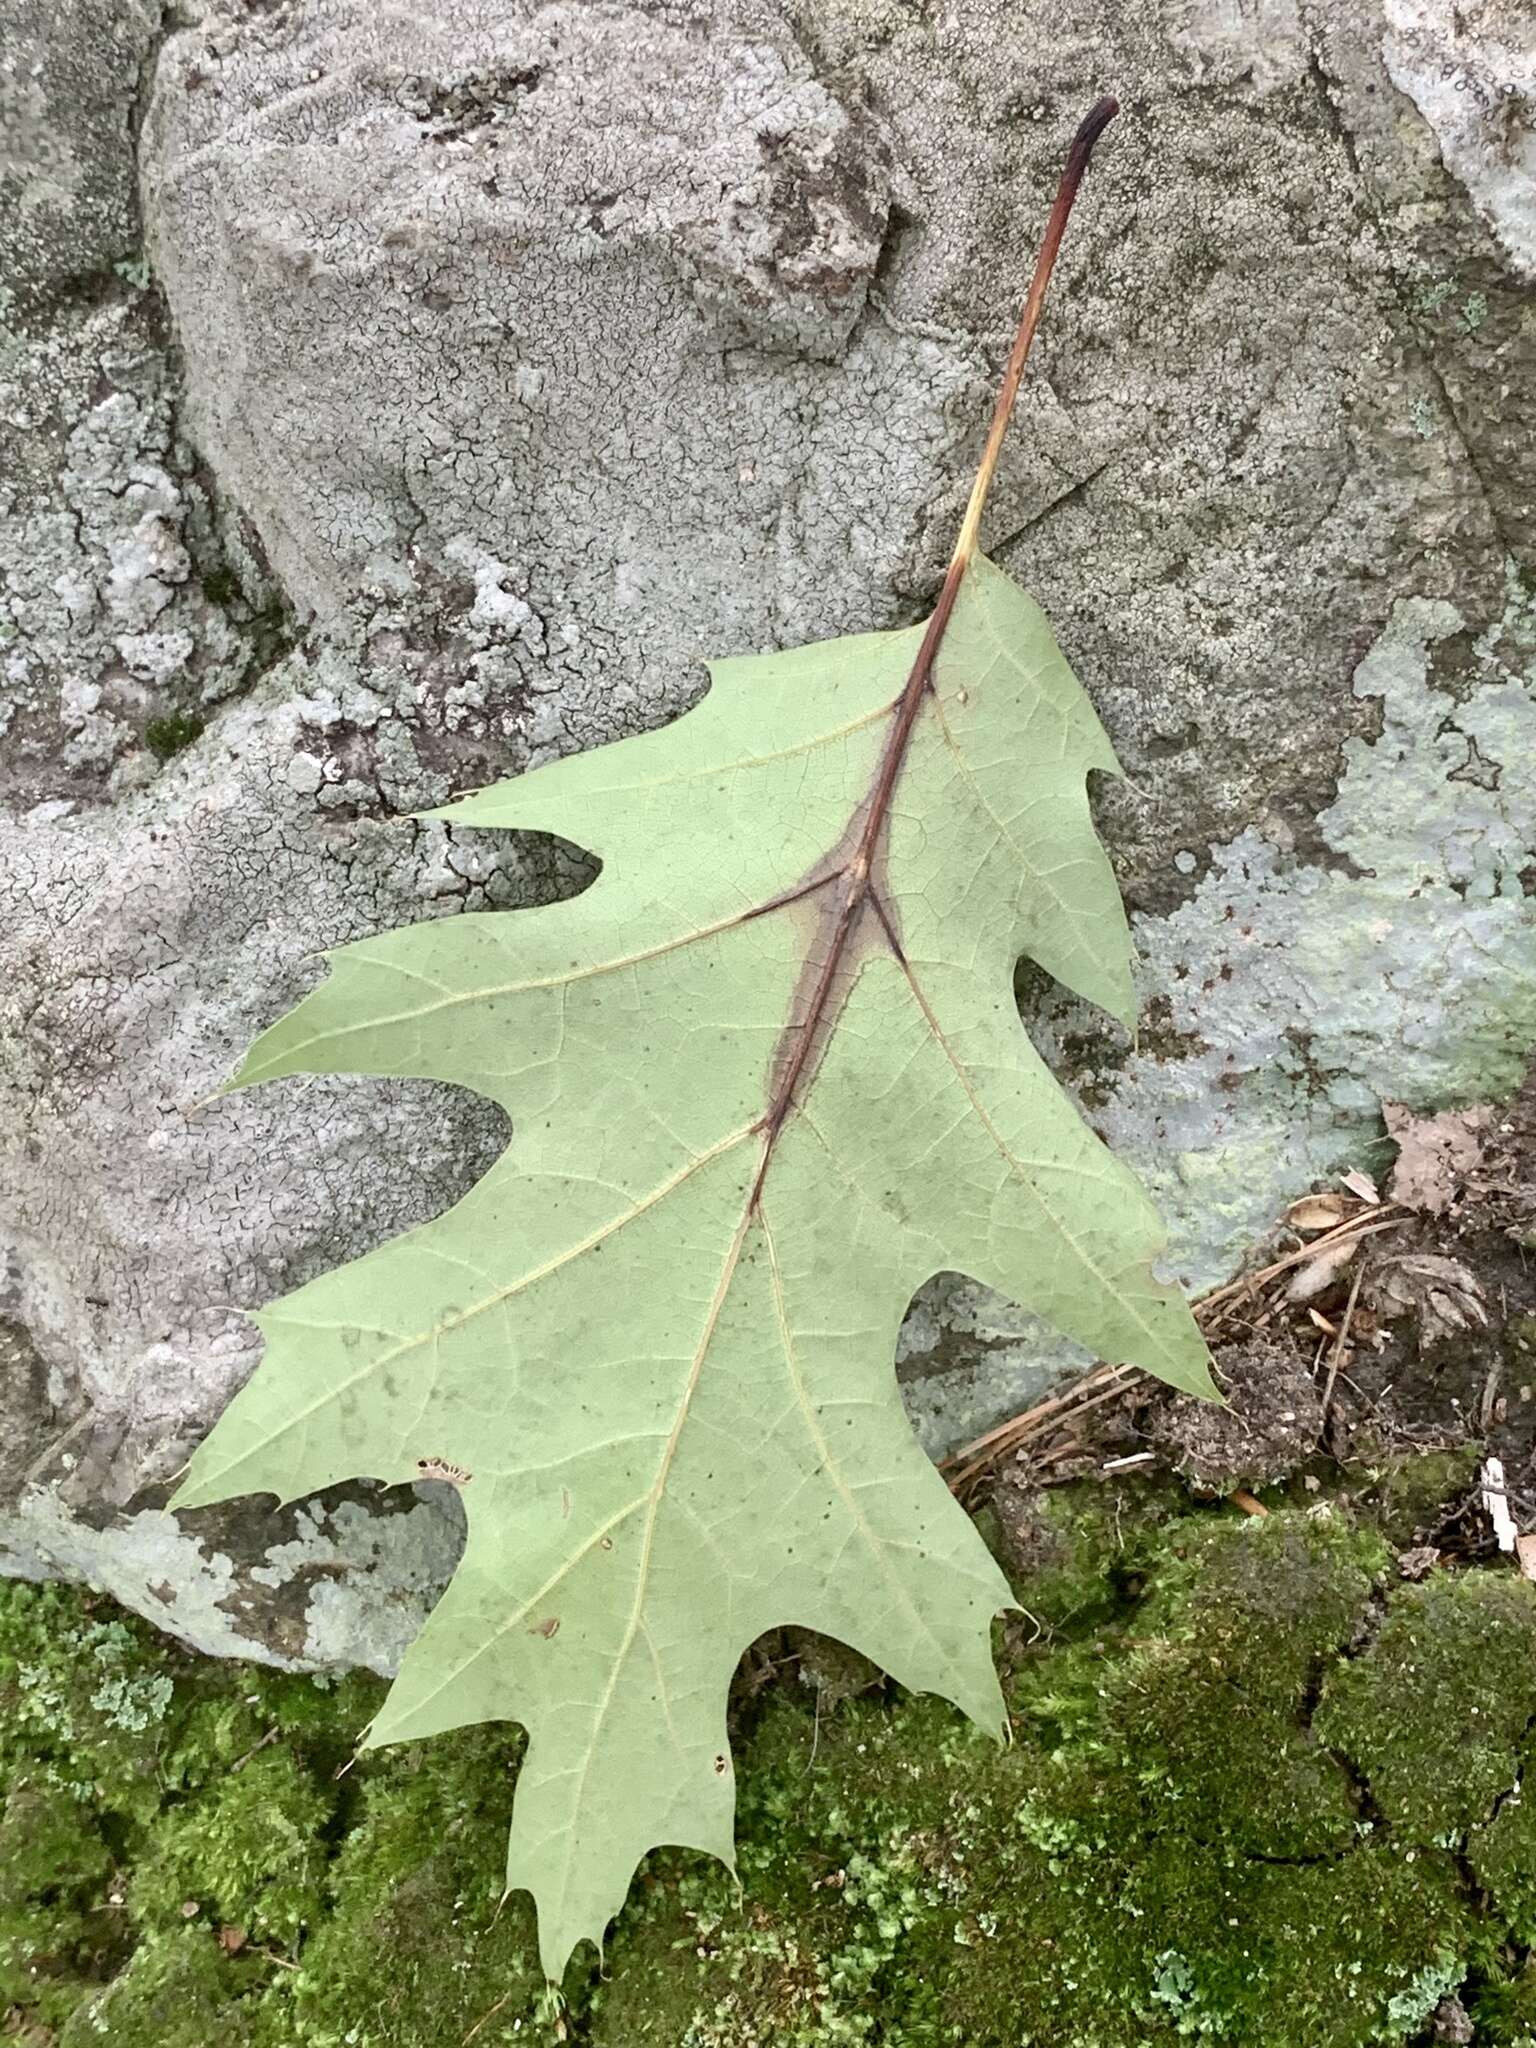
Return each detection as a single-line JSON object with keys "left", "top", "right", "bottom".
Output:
{"left": 1106, "top": 588, "right": 1536, "bottom": 1286}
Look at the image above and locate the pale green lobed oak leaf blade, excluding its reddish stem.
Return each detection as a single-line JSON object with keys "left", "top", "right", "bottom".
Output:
{"left": 172, "top": 561, "right": 1210, "bottom": 1976}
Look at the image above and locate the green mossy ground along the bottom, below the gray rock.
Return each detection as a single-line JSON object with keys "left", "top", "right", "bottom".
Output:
{"left": 0, "top": 1485, "right": 1536, "bottom": 2048}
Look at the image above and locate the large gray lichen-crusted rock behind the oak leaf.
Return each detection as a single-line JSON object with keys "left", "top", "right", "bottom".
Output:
{"left": 0, "top": 0, "right": 1536, "bottom": 1669}
